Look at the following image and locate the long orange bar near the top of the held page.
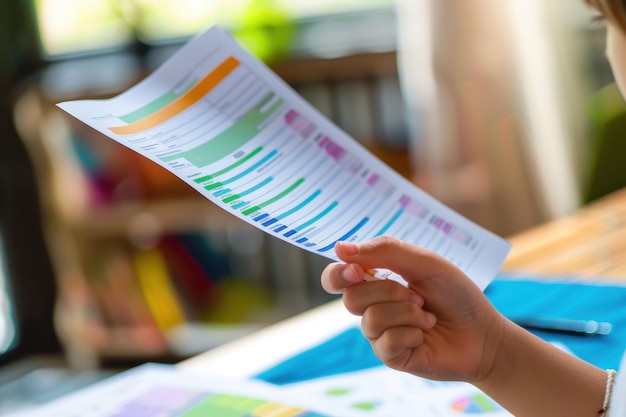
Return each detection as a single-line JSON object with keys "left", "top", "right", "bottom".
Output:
{"left": 109, "top": 56, "right": 239, "bottom": 135}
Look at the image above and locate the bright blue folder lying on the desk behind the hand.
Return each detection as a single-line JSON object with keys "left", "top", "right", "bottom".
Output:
{"left": 256, "top": 275, "right": 626, "bottom": 385}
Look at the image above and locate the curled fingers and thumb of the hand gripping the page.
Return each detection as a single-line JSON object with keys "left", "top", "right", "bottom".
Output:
{"left": 321, "top": 244, "right": 438, "bottom": 369}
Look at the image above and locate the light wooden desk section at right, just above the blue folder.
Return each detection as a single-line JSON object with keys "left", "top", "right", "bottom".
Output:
{"left": 503, "top": 189, "right": 626, "bottom": 280}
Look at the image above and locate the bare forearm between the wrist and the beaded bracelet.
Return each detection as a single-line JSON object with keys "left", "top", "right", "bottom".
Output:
{"left": 476, "top": 322, "right": 607, "bottom": 417}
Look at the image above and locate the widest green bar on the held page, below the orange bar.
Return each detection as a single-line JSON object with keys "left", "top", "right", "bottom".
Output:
{"left": 161, "top": 93, "right": 283, "bottom": 168}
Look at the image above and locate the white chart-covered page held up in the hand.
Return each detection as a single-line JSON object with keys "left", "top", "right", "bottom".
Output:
{"left": 59, "top": 27, "right": 510, "bottom": 289}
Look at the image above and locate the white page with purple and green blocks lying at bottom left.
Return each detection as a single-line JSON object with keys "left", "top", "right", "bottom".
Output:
{"left": 7, "top": 363, "right": 336, "bottom": 417}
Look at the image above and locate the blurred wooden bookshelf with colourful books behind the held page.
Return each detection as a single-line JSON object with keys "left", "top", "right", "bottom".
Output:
{"left": 14, "top": 4, "right": 412, "bottom": 368}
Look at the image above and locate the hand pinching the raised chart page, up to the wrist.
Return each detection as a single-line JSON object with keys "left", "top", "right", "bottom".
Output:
{"left": 322, "top": 237, "right": 506, "bottom": 383}
